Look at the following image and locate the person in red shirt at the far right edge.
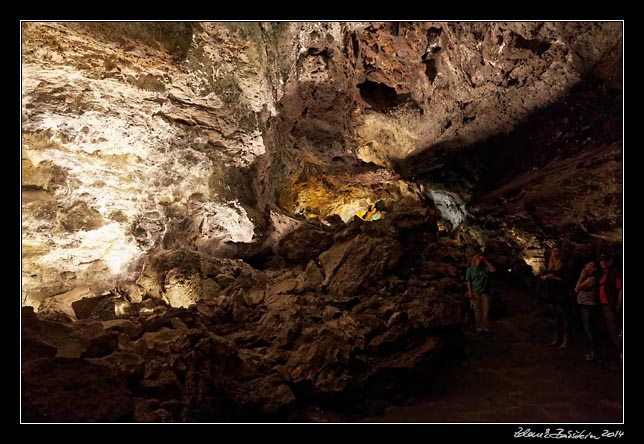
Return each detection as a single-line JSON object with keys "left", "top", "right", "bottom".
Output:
{"left": 599, "top": 254, "right": 622, "bottom": 359}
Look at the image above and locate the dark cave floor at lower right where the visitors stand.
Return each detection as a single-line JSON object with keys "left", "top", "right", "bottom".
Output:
{"left": 365, "top": 283, "right": 623, "bottom": 424}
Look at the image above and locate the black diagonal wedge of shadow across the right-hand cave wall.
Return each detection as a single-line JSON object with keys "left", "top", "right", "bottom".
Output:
{"left": 394, "top": 80, "right": 622, "bottom": 196}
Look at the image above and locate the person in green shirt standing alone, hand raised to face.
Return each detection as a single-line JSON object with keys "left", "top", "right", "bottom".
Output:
{"left": 465, "top": 253, "right": 496, "bottom": 333}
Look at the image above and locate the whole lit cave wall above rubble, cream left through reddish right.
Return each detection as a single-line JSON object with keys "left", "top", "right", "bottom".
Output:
{"left": 22, "top": 22, "right": 622, "bottom": 304}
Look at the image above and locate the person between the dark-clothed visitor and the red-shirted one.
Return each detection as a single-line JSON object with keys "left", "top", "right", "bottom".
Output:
{"left": 575, "top": 261, "right": 600, "bottom": 361}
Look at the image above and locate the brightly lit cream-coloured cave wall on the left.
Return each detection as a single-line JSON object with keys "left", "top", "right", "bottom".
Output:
{"left": 22, "top": 22, "right": 275, "bottom": 303}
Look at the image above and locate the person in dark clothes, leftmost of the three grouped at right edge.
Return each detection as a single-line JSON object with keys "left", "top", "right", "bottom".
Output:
{"left": 542, "top": 247, "right": 570, "bottom": 349}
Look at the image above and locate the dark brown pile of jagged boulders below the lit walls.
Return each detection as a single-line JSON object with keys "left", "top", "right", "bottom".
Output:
{"left": 22, "top": 199, "right": 465, "bottom": 422}
